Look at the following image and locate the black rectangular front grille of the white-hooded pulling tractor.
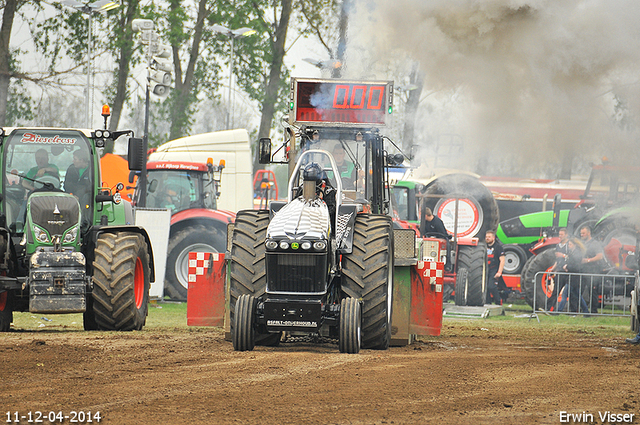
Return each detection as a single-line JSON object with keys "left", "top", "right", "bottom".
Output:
{"left": 266, "top": 252, "right": 327, "bottom": 293}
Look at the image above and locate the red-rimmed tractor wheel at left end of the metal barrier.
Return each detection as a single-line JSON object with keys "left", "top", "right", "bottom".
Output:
{"left": 521, "top": 249, "right": 558, "bottom": 310}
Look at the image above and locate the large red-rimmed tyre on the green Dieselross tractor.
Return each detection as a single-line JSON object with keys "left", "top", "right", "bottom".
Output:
{"left": 93, "top": 232, "right": 150, "bottom": 331}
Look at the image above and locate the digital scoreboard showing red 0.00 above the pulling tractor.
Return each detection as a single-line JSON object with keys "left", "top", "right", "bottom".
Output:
{"left": 289, "top": 78, "right": 393, "bottom": 127}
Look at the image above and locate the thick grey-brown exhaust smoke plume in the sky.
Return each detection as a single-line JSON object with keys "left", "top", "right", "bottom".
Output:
{"left": 344, "top": 0, "right": 640, "bottom": 177}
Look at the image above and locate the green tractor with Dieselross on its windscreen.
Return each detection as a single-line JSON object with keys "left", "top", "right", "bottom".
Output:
{"left": 0, "top": 128, "right": 154, "bottom": 332}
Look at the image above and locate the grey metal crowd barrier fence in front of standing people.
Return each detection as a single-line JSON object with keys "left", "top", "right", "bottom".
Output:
{"left": 533, "top": 271, "right": 636, "bottom": 316}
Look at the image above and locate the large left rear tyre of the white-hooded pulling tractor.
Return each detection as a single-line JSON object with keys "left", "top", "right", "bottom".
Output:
{"left": 229, "top": 210, "right": 281, "bottom": 345}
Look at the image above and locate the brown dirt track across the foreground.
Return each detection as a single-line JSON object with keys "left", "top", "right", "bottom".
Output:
{"left": 0, "top": 321, "right": 640, "bottom": 424}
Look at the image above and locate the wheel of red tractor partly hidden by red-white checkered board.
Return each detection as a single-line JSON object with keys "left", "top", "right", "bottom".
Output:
{"left": 164, "top": 224, "right": 227, "bottom": 301}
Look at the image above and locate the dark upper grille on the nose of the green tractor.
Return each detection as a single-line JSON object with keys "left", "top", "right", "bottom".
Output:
{"left": 29, "top": 195, "right": 80, "bottom": 236}
